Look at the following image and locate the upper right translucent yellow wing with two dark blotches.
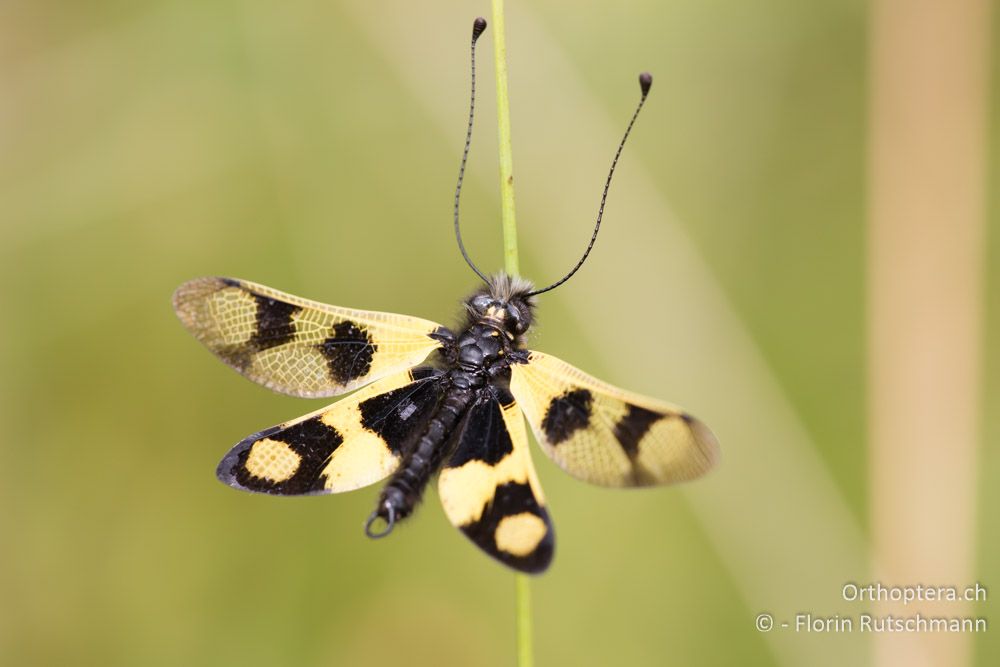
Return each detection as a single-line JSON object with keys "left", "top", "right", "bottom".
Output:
{"left": 510, "top": 352, "right": 719, "bottom": 487}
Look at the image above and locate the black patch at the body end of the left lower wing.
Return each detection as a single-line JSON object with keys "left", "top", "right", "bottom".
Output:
{"left": 358, "top": 368, "right": 444, "bottom": 455}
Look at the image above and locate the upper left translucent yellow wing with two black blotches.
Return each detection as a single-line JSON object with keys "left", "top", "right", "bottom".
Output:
{"left": 174, "top": 278, "right": 444, "bottom": 398}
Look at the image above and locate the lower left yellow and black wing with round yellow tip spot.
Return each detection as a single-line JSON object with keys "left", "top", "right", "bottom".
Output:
{"left": 216, "top": 368, "right": 444, "bottom": 495}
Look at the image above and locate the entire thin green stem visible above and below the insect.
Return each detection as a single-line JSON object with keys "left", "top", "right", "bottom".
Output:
{"left": 491, "top": 0, "right": 534, "bottom": 667}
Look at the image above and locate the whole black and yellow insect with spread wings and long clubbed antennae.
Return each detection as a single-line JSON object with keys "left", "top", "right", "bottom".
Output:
{"left": 174, "top": 19, "right": 718, "bottom": 573}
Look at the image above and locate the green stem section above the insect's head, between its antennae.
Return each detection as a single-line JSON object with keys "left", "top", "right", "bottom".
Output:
{"left": 492, "top": 0, "right": 524, "bottom": 278}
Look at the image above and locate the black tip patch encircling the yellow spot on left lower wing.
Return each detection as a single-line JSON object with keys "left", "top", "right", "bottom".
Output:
{"left": 232, "top": 416, "right": 344, "bottom": 495}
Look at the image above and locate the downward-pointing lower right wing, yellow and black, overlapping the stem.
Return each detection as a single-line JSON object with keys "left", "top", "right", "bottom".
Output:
{"left": 438, "top": 387, "right": 555, "bottom": 573}
